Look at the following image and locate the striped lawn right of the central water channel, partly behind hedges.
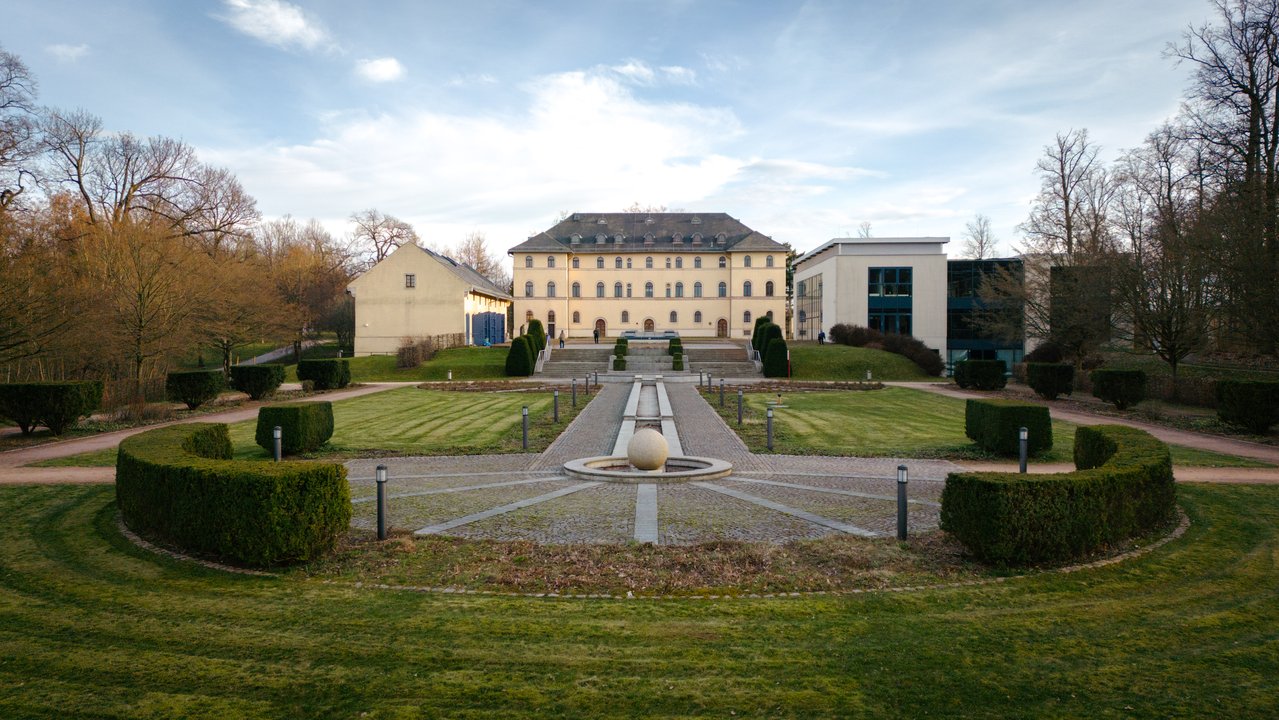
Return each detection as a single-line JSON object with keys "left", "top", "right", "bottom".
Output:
{"left": 710, "top": 387, "right": 1267, "bottom": 467}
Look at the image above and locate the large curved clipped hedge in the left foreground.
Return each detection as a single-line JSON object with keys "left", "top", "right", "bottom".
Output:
{"left": 115, "top": 423, "right": 350, "bottom": 567}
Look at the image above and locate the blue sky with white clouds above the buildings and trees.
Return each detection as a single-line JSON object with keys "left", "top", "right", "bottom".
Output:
{"left": 0, "top": 0, "right": 1211, "bottom": 256}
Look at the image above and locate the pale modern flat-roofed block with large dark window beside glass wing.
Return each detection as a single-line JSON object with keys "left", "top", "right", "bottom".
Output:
{"left": 794, "top": 238, "right": 950, "bottom": 356}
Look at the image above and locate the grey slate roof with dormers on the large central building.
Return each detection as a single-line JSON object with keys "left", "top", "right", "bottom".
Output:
{"left": 506, "top": 212, "right": 785, "bottom": 254}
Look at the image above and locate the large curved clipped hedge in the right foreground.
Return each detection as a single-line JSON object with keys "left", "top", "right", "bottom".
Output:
{"left": 941, "top": 425, "right": 1177, "bottom": 565}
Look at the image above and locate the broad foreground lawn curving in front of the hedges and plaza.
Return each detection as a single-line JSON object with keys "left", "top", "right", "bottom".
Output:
{"left": 0, "top": 485, "right": 1279, "bottom": 717}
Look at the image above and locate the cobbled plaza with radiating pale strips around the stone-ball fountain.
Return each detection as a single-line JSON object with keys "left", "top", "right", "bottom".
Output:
{"left": 347, "top": 384, "right": 961, "bottom": 545}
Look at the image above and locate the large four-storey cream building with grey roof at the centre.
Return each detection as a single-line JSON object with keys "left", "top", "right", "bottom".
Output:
{"left": 509, "top": 212, "right": 787, "bottom": 338}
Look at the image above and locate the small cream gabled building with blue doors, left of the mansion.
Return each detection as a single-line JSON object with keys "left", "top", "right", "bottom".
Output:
{"left": 347, "top": 243, "right": 510, "bottom": 356}
